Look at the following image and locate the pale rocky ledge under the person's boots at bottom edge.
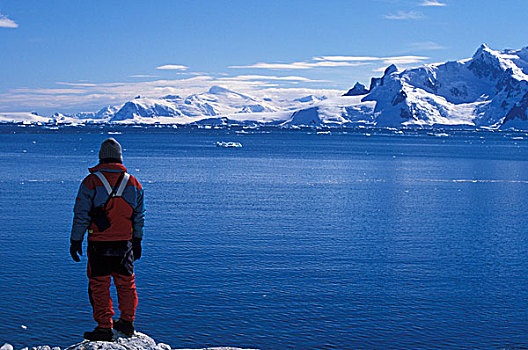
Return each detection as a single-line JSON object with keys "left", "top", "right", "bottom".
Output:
{"left": 0, "top": 332, "right": 256, "bottom": 350}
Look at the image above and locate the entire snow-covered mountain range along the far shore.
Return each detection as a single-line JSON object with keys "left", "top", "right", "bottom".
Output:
{"left": 0, "top": 44, "right": 528, "bottom": 130}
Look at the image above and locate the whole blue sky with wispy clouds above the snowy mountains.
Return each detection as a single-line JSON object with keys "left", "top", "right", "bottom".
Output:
{"left": 0, "top": 0, "right": 528, "bottom": 114}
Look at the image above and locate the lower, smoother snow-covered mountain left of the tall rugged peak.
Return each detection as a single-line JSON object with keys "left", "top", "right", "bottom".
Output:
{"left": 21, "top": 86, "right": 326, "bottom": 124}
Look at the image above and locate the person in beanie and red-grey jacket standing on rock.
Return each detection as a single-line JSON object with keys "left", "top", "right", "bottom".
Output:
{"left": 70, "top": 138, "right": 145, "bottom": 341}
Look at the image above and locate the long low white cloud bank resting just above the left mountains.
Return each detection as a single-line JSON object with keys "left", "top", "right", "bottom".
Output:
{"left": 0, "top": 75, "right": 342, "bottom": 114}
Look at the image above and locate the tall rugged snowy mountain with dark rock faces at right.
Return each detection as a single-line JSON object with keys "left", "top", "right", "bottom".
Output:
{"left": 287, "top": 45, "right": 528, "bottom": 129}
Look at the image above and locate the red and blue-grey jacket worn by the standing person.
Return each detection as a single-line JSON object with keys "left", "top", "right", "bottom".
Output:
{"left": 71, "top": 163, "right": 145, "bottom": 241}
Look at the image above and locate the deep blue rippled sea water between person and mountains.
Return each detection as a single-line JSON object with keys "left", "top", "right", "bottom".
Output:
{"left": 0, "top": 126, "right": 528, "bottom": 350}
